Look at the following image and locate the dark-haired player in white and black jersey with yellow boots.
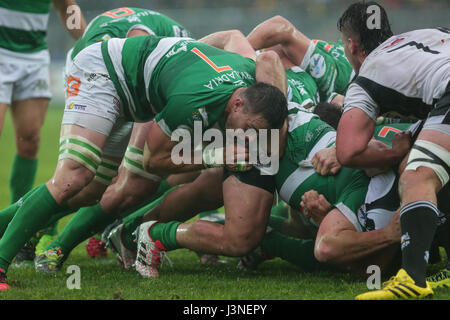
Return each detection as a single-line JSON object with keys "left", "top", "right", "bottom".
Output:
{"left": 336, "top": 2, "right": 450, "bottom": 299}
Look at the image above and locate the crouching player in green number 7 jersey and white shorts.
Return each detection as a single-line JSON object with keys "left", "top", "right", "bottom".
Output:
{"left": 0, "top": 26, "right": 287, "bottom": 290}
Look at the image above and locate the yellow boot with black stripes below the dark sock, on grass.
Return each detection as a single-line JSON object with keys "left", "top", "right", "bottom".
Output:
{"left": 355, "top": 269, "right": 433, "bottom": 300}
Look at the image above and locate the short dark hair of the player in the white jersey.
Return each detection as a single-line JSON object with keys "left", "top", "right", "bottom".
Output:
{"left": 338, "top": 1, "right": 393, "bottom": 55}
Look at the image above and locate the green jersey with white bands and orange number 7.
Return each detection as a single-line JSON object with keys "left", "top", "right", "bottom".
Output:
{"left": 101, "top": 36, "right": 255, "bottom": 129}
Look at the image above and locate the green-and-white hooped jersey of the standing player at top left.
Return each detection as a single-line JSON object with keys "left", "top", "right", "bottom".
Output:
{"left": 0, "top": 0, "right": 51, "bottom": 53}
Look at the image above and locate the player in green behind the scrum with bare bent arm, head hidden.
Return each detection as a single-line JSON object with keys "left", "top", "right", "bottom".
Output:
{"left": 247, "top": 16, "right": 353, "bottom": 105}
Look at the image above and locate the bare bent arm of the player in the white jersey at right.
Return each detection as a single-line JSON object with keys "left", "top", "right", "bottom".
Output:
{"left": 336, "top": 108, "right": 411, "bottom": 168}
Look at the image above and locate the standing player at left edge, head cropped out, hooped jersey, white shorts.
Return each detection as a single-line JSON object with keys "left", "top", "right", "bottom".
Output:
{"left": 0, "top": 0, "right": 86, "bottom": 262}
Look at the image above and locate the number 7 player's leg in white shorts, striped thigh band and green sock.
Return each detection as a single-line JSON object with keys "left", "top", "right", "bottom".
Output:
{"left": 0, "top": 46, "right": 119, "bottom": 289}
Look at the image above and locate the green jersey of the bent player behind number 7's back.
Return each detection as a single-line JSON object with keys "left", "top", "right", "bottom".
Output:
{"left": 71, "top": 7, "right": 189, "bottom": 59}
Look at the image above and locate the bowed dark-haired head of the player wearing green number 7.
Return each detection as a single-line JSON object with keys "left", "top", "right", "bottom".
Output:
{"left": 226, "top": 82, "right": 288, "bottom": 130}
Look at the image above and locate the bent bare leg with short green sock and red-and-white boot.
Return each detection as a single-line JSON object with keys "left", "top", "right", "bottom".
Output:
{"left": 136, "top": 172, "right": 273, "bottom": 277}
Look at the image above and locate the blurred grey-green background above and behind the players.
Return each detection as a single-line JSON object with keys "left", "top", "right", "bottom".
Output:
{"left": 47, "top": 0, "right": 450, "bottom": 107}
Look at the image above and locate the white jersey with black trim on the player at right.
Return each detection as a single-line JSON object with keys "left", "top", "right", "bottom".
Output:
{"left": 344, "top": 28, "right": 450, "bottom": 121}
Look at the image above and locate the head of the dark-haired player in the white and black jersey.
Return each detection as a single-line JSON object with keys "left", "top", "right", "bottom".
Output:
{"left": 338, "top": 1, "right": 393, "bottom": 72}
